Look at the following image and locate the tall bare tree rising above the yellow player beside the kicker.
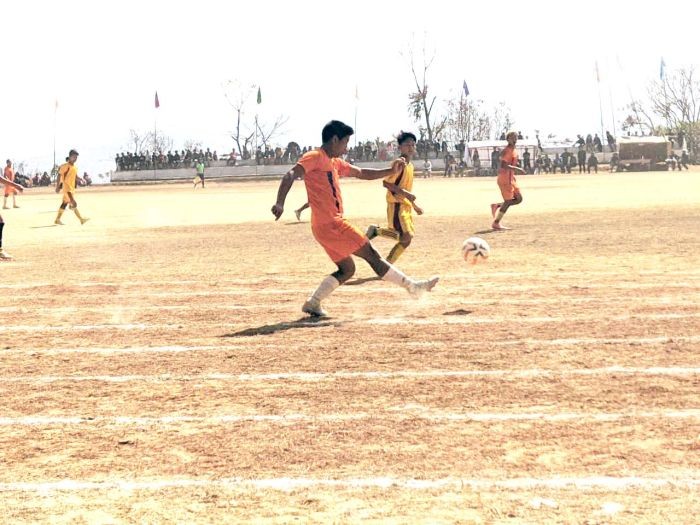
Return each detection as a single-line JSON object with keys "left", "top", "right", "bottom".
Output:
{"left": 408, "top": 36, "right": 447, "bottom": 144}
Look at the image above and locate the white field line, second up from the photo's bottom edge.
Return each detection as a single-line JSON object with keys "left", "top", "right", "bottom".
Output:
{"left": 0, "top": 406, "right": 700, "bottom": 427}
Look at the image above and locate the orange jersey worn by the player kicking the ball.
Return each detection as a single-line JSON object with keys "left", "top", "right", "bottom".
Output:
{"left": 297, "top": 148, "right": 350, "bottom": 225}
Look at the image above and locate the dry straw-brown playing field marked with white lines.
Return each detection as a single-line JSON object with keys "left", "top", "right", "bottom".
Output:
{"left": 0, "top": 168, "right": 700, "bottom": 524}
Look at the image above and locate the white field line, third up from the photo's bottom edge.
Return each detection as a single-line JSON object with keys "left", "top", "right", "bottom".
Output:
{"left": 0, "top": 366, "right": 700, "bottom": 384}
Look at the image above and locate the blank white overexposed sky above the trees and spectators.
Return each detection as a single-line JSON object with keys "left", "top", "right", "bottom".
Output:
{"left": 0, "top": 0, "right": 700, "bottom": 175}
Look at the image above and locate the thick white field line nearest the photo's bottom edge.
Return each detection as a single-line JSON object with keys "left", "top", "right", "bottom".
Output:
{"left": 0, "top": 473, "right": 700, "bottom": 493}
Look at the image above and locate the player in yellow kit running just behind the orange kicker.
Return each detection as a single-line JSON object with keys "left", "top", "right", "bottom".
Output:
{"left": 367, "top": 131, "right": 423, "bottom": 264}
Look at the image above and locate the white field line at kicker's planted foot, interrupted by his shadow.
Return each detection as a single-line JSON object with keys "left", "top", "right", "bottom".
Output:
{"left": 3, "top": 312, "right": 700, "bottom": 332}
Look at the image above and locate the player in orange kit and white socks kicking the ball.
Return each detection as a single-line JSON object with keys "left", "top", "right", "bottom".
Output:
{"left": 272, "top": 120, "right": 438, "bottom": 317}
